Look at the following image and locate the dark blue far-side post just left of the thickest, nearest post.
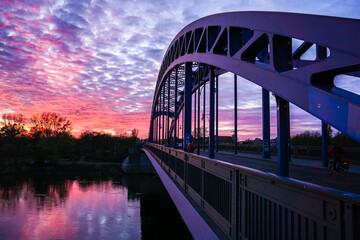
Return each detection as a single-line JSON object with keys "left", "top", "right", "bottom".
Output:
{"left": 262, "top": 88, "right": 270, "bottom": 158}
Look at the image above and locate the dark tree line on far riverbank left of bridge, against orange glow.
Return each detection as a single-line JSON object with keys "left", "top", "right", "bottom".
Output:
{"left": 0, "top": 112, "right": 139, "bottom": 164}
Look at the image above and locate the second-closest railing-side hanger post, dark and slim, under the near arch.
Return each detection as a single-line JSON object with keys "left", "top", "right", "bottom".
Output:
{"left": 209, "top": 67, "right": 215, "bottom": 158}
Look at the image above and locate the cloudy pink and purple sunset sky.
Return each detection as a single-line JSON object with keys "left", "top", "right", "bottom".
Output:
{"left": 0, "top": 0, "right": 360, "bottom": 139}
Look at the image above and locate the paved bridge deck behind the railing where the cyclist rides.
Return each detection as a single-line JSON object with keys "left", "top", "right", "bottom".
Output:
{"left": 201, "top": 151, "right": 360, "bottom": 175}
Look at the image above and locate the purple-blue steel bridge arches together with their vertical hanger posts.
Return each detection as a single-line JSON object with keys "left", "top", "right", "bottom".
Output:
{"left": 149, "top": 12, "right": 360, "bottom": 176}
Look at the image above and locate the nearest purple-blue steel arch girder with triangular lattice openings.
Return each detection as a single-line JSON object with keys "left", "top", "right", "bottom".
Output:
{"left": 150, "top": 12, "right": 360, "bottom": 141}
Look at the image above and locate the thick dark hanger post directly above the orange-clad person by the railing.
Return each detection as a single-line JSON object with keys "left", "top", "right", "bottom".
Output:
{"left": 183, "top": 62, "right": 192, "bottom": 147}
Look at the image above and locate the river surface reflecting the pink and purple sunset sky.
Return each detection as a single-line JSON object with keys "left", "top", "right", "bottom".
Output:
{"left": 0, "top": 176, "right": 191, "bottom": 239}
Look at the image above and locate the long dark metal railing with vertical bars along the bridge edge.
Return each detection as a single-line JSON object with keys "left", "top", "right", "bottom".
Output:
{"left": 144, "top": 143, "right": 360, "bottom": 240}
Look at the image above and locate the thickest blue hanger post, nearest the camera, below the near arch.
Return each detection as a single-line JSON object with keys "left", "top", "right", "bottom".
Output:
{"left": 276, "top": 96, "right": 290, "bottom": 177}
